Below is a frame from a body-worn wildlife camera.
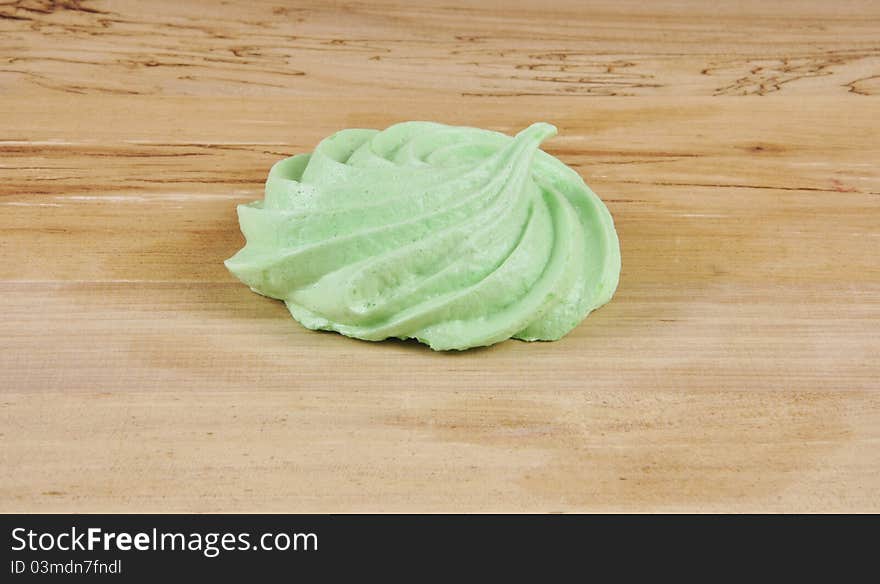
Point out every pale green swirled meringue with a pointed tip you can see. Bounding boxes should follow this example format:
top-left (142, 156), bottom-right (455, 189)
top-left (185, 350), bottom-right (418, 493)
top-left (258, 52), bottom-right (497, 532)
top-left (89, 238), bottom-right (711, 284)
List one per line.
top-left (226, 122), bottom-right (620, 350)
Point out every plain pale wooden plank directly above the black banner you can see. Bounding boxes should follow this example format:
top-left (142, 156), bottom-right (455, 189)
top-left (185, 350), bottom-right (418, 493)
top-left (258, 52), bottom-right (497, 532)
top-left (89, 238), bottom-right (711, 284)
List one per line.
top-left (0, 388), bottom-right (880, 512)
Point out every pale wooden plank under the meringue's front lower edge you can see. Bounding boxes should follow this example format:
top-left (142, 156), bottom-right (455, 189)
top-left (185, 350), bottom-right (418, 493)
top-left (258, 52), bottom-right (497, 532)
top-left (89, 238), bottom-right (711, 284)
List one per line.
top-left (0, 279), bottom-right (880, 394)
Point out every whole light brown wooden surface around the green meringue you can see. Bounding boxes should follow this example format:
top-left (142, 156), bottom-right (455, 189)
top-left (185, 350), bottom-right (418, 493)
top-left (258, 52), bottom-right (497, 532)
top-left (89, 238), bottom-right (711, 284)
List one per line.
top-left (0, 0), bottom-right (880, 512)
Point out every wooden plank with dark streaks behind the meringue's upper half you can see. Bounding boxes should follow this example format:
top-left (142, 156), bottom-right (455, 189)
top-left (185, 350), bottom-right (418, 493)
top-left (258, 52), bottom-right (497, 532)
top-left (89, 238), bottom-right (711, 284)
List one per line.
top-left (0, 96), bottom-right (880, 288)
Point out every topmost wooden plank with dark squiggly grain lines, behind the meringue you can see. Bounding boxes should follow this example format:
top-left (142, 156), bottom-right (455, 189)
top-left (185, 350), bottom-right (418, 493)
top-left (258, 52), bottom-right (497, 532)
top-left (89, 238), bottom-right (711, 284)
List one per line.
top-left (0, 0), bottom-right (880, 97)
